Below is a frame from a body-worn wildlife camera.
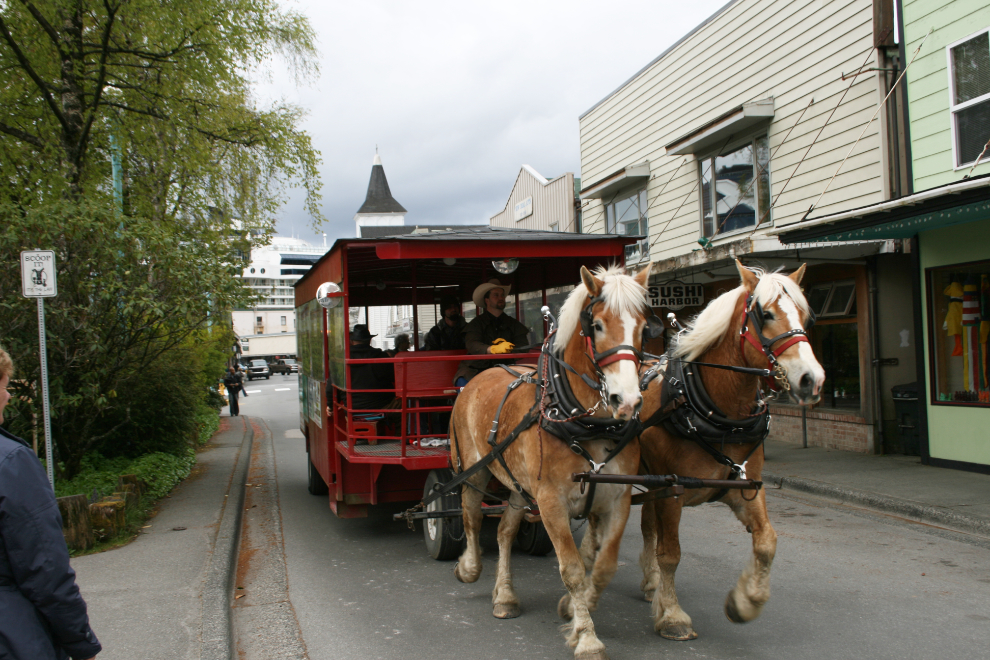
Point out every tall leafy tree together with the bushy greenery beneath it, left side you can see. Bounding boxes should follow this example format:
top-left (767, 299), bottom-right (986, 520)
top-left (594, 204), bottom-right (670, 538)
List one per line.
top-left (0, 0), bottom-right (321, 478)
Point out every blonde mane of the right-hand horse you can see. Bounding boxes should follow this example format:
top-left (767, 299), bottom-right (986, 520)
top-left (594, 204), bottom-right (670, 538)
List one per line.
top-left (674, 268), bottom-right (808, 361)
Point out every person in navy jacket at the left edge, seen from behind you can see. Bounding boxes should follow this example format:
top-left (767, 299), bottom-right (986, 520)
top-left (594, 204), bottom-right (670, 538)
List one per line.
top-left (0, 348), bottom-right (103, 660)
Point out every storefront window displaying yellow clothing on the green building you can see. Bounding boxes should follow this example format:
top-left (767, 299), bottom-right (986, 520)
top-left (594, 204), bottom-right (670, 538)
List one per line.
top-left (928, 261), bottom-right (990, 405)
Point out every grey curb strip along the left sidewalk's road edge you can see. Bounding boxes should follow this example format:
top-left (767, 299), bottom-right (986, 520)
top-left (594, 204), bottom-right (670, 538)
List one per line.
top-left (200, 417), bottom-right (254, 660)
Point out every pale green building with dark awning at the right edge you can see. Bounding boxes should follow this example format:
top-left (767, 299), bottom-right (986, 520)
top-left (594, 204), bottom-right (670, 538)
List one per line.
top-left (780, 0), bottom-right (990, 473)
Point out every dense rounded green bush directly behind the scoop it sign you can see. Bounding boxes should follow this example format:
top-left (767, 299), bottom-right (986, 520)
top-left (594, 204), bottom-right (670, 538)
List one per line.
top-left (0, 201), bottom-right (250, 478)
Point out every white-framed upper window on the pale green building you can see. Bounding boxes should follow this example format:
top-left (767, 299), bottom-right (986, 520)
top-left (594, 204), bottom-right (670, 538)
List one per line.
top-left (948, 30), bottom-right (990, 168)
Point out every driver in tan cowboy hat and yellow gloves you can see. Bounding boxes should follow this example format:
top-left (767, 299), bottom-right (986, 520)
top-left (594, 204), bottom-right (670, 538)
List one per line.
top-left (454, 280), bottom-right (529, 387)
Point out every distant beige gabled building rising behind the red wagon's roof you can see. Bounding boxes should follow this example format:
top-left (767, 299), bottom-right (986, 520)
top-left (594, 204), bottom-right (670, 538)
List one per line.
top-left (489, 165), bottom-right (579, 232)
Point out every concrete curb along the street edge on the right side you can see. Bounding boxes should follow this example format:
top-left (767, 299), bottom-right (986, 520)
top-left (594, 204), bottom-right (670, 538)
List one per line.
top-left (763, 472), bottom-right (990, 537)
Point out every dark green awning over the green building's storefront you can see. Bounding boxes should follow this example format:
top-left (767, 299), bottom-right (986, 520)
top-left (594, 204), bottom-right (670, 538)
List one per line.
top-left (767, 174), bottom-right (990, 244)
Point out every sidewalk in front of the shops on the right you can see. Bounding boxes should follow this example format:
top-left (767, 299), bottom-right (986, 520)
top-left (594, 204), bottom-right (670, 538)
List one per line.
top-left (763, 440), bottom-right (990, 537)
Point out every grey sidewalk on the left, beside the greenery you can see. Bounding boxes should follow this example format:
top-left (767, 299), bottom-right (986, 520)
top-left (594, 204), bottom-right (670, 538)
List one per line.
top-left (72, 416), bottom-right (253, 660)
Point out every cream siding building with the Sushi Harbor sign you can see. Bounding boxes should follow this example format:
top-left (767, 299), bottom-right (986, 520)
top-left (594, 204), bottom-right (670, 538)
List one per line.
top-left (579, 0), bottom-right (914, 452)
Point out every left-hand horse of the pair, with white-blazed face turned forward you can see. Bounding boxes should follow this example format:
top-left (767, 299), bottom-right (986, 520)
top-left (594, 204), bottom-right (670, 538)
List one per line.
top-left (450, 266), bottom-right (652, 660)
